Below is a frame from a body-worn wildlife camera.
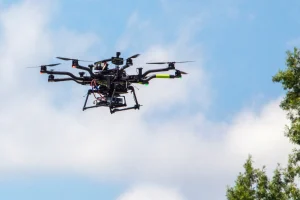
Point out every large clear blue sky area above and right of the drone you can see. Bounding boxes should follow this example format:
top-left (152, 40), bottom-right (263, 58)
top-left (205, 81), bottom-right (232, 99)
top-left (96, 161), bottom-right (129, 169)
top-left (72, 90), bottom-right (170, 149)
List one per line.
top-left (45, 1), bottom-right (300, 119)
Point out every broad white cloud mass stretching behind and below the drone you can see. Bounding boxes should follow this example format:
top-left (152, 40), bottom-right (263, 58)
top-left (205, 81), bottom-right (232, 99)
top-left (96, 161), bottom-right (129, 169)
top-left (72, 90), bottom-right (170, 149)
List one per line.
top-left (0, 1), bottom-right (291, 200)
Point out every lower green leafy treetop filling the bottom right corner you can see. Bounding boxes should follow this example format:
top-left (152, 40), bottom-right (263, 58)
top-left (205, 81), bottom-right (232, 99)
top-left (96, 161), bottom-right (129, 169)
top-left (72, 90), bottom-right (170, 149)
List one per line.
top-left (226, 155), bottom-right (300, 200)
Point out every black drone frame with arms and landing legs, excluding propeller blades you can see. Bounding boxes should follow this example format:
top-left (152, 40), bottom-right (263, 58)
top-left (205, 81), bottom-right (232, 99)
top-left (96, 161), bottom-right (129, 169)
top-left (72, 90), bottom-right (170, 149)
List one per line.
top-left (40, 55), bottom-right (186, 114)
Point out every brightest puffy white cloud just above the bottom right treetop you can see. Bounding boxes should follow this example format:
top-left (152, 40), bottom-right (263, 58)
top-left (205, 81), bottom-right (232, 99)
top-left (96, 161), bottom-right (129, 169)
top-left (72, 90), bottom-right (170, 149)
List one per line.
top-left (228, 98), bottom-right (291, 167)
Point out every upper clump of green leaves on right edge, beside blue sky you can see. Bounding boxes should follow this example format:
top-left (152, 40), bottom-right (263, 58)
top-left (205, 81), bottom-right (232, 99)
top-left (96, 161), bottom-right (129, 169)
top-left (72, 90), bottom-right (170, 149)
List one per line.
top-left (272, 48), bottom-right (300, 145)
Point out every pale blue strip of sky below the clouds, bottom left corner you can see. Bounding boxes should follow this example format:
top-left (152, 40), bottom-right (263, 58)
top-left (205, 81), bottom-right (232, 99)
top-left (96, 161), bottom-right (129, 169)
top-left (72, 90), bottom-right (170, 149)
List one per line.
top-left (0, 176), bottom-right (123, 200)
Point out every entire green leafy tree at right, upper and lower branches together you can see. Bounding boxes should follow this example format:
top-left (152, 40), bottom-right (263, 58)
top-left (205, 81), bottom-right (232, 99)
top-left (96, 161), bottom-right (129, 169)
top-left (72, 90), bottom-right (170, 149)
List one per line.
top-left (226, 48), bottom-right (300, 200)
